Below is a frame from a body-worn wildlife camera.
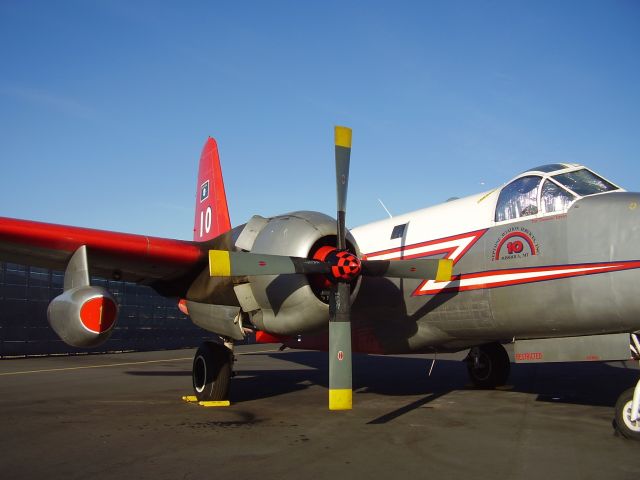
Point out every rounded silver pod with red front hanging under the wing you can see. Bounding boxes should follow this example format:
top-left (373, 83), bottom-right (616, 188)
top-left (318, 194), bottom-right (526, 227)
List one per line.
top-left (47, 285), bottom-right (118, 348)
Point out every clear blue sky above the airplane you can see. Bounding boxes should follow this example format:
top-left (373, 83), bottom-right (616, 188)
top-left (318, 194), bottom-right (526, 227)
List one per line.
top-left (0, 0), bottom-right (640, 239)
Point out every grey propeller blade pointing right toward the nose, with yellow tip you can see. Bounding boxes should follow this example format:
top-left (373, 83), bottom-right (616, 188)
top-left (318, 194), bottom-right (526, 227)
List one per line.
top-left (362, 258), bottom-right (453, 282)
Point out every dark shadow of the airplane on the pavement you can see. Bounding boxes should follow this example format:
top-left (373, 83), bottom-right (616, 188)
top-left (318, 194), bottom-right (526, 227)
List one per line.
top-left (126, 351), bottom-right (640, 423)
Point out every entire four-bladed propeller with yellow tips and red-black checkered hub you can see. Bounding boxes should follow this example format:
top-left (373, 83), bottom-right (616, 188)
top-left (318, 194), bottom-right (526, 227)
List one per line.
top-left (209, 126), bottom-right (453, 410)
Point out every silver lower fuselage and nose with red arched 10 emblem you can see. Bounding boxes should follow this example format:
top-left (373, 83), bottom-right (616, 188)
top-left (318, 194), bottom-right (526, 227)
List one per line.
top-left (353, 192), bottom-right (640, 353)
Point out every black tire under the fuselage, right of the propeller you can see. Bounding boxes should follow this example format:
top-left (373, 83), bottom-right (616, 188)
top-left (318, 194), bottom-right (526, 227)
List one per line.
top-left (467, 343), bottom-right (511, 388)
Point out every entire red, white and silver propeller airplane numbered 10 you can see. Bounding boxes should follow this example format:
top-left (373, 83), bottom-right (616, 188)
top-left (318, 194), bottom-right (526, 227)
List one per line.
top-left (0, 127), bottom-right (640, 440)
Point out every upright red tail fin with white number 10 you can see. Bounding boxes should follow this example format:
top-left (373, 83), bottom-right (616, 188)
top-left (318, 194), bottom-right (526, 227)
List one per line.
top-left (193, 137), bottom-right (231, 242)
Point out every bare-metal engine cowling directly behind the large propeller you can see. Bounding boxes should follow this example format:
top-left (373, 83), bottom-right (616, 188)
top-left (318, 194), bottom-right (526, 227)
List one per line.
top-left (240, 211), bottom-right (360, 335)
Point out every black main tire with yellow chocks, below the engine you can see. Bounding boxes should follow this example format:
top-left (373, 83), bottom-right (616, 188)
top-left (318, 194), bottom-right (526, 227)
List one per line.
top-left (191, 342), bottom-right (232, 402)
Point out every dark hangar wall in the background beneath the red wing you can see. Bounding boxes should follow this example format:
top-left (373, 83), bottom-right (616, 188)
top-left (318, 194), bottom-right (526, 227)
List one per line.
top-left (0, 263), bottom-right (218, 358)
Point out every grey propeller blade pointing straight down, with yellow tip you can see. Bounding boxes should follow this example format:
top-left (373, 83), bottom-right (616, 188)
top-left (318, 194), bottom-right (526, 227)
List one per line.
top-left (329, 282), bottom-right (353, 410)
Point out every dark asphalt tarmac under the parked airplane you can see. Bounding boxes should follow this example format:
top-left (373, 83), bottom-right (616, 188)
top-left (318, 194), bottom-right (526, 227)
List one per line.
top-left (0, 345), bottom-right (640, 480)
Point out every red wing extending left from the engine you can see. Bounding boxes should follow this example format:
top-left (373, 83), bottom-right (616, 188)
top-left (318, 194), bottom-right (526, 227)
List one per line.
top-left (0, 217), bottom-right (206, 284)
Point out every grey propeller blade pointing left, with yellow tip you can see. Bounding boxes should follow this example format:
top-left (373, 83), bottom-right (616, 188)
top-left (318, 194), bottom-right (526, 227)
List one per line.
top-left (209, 250), bottom-right (331, 277)
